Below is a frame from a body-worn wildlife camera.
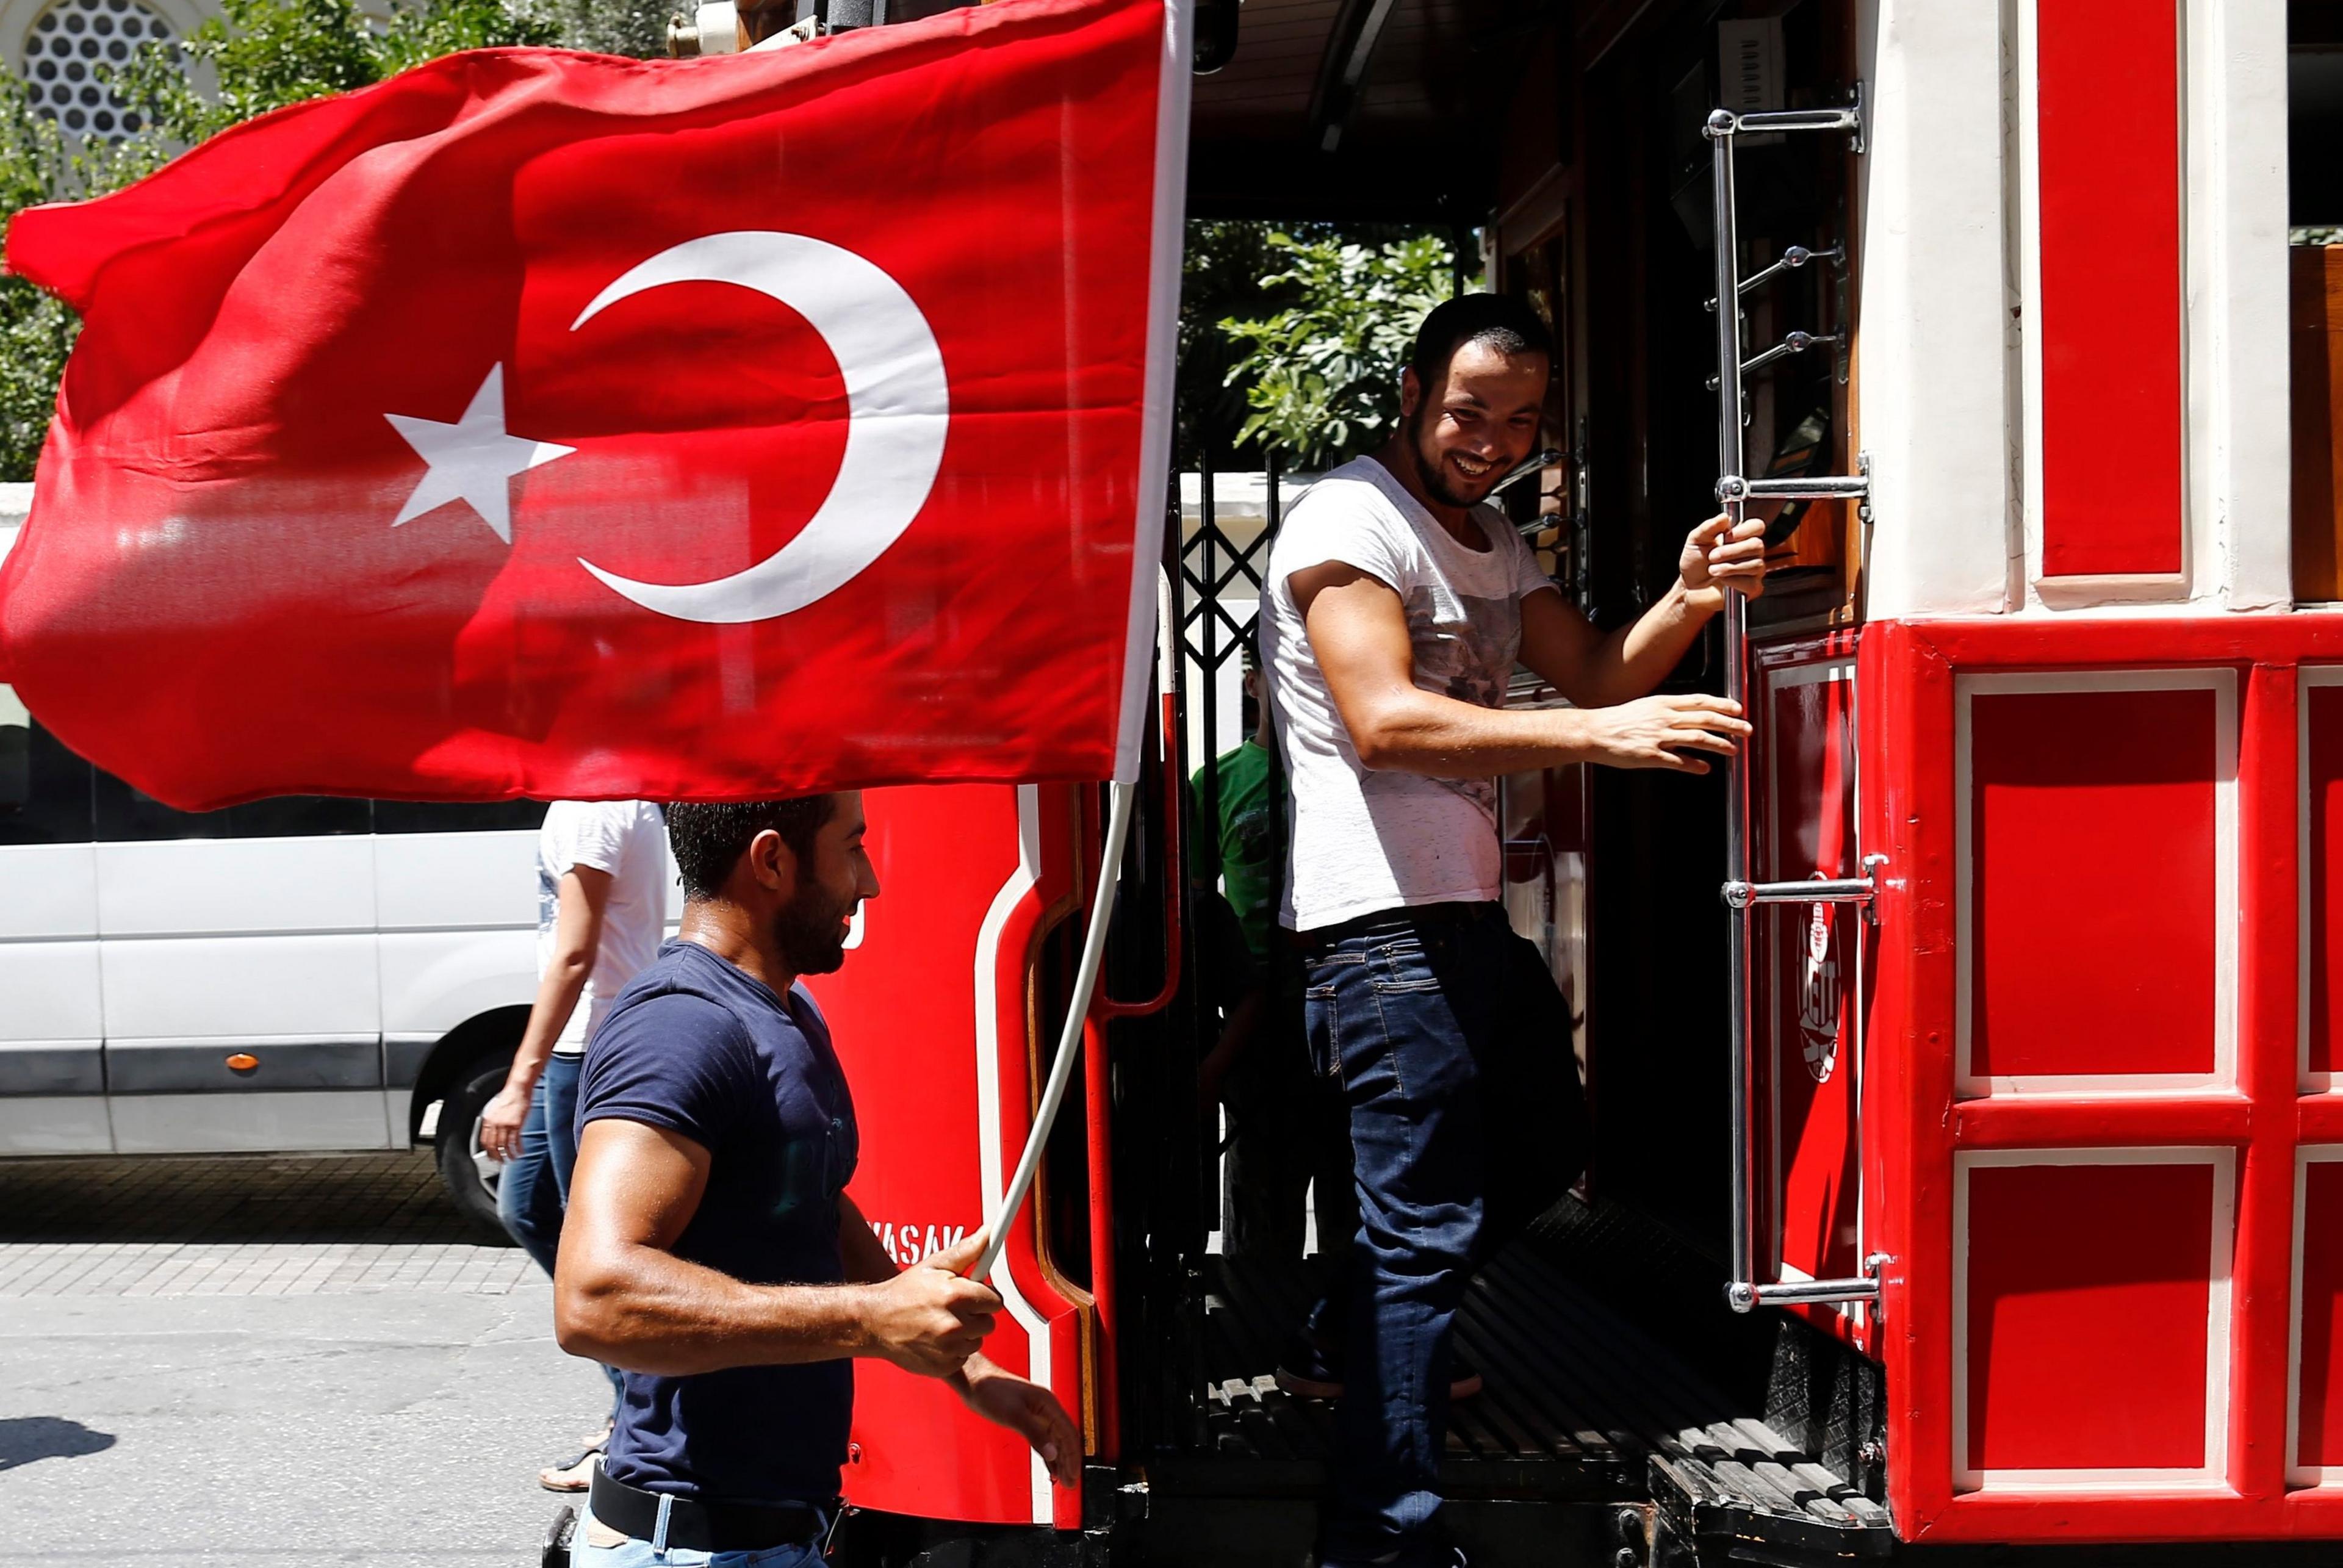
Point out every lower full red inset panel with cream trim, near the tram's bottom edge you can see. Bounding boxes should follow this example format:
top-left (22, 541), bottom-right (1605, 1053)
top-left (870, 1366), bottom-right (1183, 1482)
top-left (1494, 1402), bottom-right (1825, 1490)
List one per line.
top-left (1966, 1165), bottom-right (2228, 1470)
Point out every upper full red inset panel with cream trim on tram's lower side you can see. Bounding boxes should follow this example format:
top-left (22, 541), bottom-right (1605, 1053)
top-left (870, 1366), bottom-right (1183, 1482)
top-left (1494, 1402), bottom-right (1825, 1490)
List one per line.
top-left (1968, 689), bottom-right (2217, 1078)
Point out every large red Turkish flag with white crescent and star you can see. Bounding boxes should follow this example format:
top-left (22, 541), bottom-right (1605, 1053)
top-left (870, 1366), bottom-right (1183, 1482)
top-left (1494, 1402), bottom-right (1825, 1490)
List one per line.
top-left (0, 0), bottom-right (1188, 808)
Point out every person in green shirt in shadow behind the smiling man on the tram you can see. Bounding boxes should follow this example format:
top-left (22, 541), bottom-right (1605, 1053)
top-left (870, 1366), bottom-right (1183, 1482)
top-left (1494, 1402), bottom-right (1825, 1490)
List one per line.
top-left (1188, 638), bottom-right (1359, 1261)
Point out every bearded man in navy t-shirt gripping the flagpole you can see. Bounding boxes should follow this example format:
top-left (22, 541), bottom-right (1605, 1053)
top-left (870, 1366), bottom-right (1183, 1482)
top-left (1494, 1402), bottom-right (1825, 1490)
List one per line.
top-left (553, 792), bottom-right (1082, 1568)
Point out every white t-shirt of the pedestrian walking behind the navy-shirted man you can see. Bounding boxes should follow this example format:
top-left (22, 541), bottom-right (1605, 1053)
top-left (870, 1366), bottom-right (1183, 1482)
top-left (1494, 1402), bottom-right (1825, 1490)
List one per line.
top-left (536, 799), bottom-right (668, 1057)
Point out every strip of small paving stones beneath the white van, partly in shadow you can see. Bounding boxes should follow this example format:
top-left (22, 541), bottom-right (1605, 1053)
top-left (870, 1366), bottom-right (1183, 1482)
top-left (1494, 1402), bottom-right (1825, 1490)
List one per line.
top-left (0, 1151), bottom-right (536, 1298)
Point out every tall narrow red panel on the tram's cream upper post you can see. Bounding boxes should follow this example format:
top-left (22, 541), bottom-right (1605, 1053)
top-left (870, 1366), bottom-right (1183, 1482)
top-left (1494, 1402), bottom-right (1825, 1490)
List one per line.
top-left (2034, 0), bottom-right (2181, 577)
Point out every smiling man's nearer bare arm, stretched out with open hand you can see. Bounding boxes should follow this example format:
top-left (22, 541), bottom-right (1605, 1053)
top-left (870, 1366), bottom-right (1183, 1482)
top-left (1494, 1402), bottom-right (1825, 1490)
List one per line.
top-left (1286, 560), bottom-right (1748, 778)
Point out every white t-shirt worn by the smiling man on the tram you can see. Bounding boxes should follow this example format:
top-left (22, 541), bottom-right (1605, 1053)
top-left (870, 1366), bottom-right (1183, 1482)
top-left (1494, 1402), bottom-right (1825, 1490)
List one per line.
top-left (1261, 457), bottom-right (1553, 930)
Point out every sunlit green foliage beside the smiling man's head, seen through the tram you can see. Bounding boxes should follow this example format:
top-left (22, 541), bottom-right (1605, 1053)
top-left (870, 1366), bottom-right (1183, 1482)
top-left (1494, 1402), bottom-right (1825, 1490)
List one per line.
top-left (1218, 232), bottom-right (1455, 469)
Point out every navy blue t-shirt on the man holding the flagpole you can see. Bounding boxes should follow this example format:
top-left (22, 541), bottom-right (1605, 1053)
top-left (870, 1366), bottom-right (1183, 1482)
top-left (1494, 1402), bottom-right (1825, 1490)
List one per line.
top-left (578, 942), bottom-right (857, 1505)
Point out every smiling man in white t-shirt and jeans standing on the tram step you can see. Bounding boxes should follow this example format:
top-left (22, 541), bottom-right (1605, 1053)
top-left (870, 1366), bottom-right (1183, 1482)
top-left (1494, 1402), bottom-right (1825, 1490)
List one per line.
top-left (1261, 295), bottom-right (1765, 1568)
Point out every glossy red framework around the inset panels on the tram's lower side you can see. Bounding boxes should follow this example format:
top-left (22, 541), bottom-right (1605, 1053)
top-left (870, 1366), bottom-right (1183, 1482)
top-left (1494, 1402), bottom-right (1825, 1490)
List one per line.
top-left (1860, 612), bottom-right (2343, 1556)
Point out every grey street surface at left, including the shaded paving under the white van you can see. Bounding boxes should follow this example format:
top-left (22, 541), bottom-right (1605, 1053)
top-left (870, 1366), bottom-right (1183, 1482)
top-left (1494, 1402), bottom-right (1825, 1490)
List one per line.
top-left (0, 1156), bottom-right (607, 1568)
